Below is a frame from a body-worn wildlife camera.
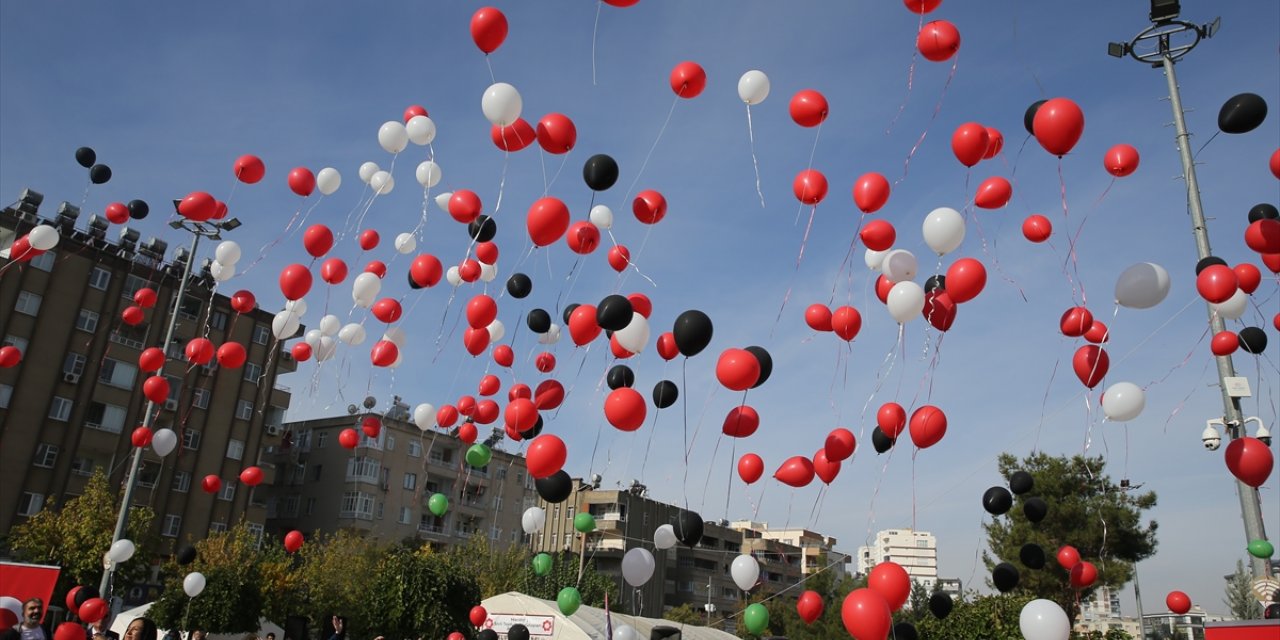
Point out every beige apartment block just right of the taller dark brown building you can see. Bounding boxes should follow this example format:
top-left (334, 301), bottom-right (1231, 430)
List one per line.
top-left (264, 398), bottom-right (538, 547)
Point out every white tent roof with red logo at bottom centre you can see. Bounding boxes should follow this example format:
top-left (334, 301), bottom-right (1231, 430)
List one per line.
top-left (481, 591), bottom-right (737, 640)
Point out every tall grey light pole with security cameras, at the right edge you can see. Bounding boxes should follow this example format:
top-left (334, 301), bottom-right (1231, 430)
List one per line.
top-left (1107, 5), bottom-right (1270, 580)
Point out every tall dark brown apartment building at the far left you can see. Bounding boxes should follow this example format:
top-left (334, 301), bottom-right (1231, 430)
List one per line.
top-left (0, 189), bottom-right (296, 550)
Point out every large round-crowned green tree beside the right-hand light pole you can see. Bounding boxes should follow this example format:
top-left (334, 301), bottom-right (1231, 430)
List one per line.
top-left (983, 453), bottom-right (1156, 626)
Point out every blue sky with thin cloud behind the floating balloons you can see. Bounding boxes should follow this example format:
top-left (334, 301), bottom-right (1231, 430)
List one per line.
top-left (0, 0), bottom-right (1280, 613)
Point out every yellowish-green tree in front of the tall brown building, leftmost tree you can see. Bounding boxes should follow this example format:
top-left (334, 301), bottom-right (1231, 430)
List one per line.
top-left (9, 470), bottom-right (157, 602)
